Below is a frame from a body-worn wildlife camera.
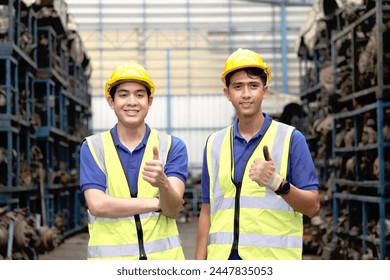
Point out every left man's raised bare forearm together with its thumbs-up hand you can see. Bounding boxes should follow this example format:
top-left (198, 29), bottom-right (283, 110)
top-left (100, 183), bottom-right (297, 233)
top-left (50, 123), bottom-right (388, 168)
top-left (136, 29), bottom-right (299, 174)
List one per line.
top-left (142, 147), bottom-right (185, 218)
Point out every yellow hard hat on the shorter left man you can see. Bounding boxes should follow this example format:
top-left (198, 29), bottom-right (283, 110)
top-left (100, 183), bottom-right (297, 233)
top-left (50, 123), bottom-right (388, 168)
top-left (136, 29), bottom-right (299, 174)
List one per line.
top-left (104, 61), bottom-right (155, 99)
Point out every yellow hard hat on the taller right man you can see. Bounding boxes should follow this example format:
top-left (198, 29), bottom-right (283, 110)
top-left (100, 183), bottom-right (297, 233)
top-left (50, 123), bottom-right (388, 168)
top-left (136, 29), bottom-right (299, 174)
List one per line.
top-left (221, 48), bottom-right (272, 85)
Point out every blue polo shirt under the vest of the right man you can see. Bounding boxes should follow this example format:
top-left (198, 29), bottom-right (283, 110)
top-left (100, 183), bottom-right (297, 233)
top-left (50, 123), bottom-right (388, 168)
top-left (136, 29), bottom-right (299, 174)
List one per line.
top-left (202, 113), bottom-right (318, 203)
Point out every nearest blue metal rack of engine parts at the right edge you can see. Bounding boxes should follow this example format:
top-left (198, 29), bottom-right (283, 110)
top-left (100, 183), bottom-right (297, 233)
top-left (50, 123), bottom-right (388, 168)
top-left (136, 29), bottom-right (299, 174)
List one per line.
top-left (332, 1), bottom-right (390, 259)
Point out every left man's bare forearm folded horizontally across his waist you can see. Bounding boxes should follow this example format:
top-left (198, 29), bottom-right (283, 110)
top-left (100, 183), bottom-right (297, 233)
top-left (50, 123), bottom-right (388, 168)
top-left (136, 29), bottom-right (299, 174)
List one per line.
top-left (84, 189), bottom-right (160, 218)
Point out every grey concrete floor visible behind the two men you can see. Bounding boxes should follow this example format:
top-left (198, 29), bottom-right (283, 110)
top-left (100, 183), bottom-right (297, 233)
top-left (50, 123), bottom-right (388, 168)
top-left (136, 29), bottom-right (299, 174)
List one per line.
top-left (38, 217), bottom-right (198, 260)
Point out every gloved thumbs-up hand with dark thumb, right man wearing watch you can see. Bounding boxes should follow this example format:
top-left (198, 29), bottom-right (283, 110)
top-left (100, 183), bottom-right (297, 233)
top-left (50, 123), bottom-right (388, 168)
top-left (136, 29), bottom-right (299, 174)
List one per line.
top-left (249, 146), bottom-right (283, 191)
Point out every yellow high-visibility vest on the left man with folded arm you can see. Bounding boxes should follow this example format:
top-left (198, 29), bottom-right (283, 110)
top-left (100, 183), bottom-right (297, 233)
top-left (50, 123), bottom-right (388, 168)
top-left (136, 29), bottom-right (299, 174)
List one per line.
top-left (86, 129), bottom-right (184, 260)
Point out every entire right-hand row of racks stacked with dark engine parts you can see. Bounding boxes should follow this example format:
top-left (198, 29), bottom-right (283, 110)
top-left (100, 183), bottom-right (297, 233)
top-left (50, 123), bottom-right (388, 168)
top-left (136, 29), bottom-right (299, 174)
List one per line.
top-left (297, 0), bottom-right (390, 259)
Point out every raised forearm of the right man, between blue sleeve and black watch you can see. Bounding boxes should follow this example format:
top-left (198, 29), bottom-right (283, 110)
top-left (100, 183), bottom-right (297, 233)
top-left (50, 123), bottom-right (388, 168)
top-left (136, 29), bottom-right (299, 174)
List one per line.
top-left (282, 187), bottom-right (320, 217)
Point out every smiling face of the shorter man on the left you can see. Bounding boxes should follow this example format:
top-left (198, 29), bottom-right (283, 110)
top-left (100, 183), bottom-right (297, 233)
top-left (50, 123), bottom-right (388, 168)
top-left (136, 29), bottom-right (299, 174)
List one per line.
top-left (108, 82), bottom-right (153, 128)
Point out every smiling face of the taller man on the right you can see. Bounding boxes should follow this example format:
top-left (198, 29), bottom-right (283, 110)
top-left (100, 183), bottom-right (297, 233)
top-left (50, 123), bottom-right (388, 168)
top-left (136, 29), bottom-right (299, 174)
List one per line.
top-left (224, 70), bottom-right (268, 120)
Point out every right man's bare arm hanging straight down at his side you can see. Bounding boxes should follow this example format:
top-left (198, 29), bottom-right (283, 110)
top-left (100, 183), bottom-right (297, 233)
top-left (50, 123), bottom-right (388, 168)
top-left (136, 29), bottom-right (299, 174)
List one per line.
top-left (195, 203), bottom-right (210, 260)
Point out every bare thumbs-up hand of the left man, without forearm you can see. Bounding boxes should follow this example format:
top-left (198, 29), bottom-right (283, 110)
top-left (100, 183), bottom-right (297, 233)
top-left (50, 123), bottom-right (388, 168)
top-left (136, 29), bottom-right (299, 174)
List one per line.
top-left (142, 147), bottom-right (169, 188)
